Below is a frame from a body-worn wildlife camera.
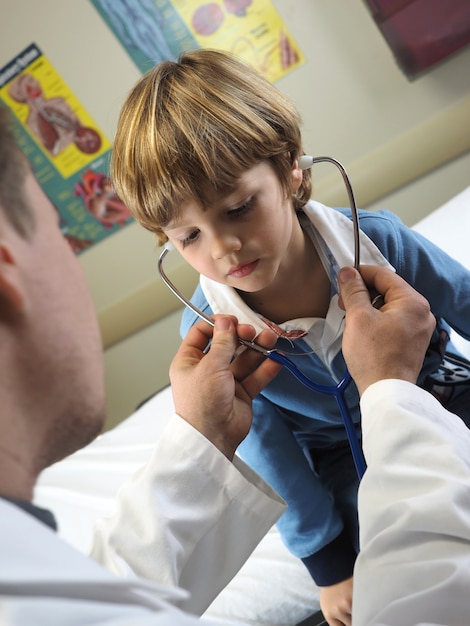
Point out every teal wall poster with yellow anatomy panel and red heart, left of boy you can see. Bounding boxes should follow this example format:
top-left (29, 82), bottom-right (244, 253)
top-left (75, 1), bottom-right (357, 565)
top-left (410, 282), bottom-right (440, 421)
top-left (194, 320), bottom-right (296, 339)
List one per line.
top-left (0, 44), bottom-right (132, 253)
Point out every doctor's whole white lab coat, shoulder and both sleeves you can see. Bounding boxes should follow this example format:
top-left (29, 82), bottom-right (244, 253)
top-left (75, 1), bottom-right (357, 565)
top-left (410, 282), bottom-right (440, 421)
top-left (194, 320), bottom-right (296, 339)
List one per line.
top-left (4, 380), bottom-right (470, 626)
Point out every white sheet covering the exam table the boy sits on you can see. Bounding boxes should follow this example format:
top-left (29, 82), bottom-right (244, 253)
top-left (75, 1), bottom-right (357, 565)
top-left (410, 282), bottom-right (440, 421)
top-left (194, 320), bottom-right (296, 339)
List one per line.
top-left (35, 187), bottom-right (470, 626)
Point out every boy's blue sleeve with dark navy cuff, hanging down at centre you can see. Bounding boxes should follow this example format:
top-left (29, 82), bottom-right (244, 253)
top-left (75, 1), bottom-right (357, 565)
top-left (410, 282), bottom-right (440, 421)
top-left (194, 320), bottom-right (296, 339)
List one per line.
top-left (238, 395), bottom-right (356, 586)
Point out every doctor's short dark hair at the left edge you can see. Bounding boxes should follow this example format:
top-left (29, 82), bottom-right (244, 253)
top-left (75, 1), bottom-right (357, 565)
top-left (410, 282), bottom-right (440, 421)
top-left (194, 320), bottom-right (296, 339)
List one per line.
top-left (0, 105), bottom-right (35, 237)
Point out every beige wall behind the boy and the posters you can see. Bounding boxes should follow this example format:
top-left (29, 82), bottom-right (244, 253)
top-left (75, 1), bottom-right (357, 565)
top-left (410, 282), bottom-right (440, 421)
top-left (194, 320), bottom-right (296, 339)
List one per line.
top-left (0, 0), bottom-right (470, 423)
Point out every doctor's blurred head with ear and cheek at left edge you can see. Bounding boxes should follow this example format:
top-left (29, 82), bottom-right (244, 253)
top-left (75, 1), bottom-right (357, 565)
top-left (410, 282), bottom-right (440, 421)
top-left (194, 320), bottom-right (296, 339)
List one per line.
top-left (0, 107), bottom-right (104, 499)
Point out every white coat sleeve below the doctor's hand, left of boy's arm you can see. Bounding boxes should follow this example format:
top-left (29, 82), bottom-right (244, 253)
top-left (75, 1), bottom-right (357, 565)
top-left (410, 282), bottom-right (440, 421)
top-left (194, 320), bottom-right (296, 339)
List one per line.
top-left (92, 415), bottom-right (285, 615)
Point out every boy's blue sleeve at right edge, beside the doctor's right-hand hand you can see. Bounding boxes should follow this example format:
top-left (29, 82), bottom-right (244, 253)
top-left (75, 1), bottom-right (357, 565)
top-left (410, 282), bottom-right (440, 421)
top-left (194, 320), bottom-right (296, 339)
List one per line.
top-left (360, 211), bottom-right (470, 339)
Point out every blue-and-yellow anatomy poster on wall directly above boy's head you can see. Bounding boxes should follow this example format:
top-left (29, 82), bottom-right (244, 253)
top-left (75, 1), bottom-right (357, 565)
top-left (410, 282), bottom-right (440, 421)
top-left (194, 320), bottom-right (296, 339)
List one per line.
top-left (90, 0), bottom-right (305, 82)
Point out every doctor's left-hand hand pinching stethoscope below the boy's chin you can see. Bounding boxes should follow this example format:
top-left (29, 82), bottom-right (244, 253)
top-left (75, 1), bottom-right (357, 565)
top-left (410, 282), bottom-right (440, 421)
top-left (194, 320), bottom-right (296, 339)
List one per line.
top-left (170, 315), bottom-right (281, 460)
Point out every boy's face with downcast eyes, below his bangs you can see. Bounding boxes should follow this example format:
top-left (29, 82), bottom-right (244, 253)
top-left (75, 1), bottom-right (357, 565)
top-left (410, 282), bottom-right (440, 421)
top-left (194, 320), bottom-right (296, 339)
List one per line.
top-left (164, 162), bottom-right (303, 293)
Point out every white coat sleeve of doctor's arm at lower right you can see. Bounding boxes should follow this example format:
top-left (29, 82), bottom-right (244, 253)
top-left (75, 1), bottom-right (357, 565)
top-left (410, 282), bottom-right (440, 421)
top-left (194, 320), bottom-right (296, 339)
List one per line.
top-left (353, 380), bottom-right (470, 626)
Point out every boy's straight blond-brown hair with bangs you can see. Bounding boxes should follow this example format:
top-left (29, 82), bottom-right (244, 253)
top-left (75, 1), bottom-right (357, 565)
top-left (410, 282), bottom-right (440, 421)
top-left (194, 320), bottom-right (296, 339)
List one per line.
top-left (111, 49), bottom-right (311, 243)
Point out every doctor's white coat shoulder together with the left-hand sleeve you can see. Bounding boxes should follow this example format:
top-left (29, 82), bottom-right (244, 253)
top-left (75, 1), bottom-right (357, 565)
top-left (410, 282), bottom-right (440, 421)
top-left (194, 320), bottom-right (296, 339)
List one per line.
top-left (0, 416), bottom-right (284, 626)
